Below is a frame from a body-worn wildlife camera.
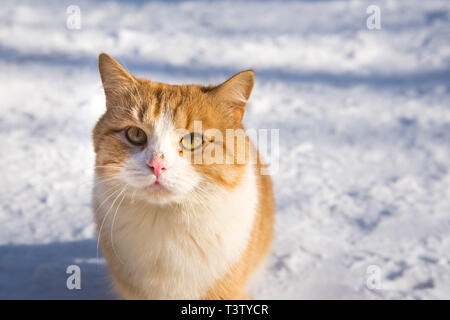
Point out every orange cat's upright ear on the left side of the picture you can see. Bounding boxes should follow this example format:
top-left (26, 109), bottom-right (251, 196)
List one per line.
top-left (98, 53), bottom-right (136, 107)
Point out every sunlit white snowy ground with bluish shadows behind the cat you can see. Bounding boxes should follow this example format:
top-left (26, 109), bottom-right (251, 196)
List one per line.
top-left (0, 0), bottom-right (450, 299)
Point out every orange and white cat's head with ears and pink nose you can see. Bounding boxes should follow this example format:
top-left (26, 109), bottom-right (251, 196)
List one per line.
top-left (93, 54), bottom-right (253, 203)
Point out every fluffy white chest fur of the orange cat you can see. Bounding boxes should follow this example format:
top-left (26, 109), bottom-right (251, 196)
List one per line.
top-left (94, 166), bottom-right (258, 299)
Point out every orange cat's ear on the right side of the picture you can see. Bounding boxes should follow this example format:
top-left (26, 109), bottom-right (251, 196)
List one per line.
top-left (210, 70), bottom-right (255, 123)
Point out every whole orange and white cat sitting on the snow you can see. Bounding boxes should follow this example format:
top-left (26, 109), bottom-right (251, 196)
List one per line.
top-left (92, 53), bottom-right (274, 299)
